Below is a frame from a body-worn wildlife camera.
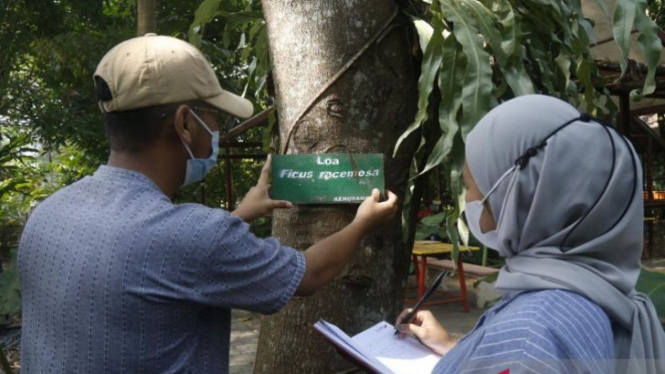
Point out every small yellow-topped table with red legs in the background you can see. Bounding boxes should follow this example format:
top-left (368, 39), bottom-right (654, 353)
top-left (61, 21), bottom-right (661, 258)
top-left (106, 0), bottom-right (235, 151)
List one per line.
top-left (406, 240), bottom-right (481, 313)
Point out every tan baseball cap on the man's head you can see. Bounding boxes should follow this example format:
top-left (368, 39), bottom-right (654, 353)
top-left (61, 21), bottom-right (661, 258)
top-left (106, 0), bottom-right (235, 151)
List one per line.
top-left (95, 34), bottom-right (254, 118)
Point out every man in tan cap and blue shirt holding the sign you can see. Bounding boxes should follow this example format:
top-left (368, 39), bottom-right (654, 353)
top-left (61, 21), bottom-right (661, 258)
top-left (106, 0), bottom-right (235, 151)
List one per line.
top-left (19, 35), bottom-right (396, 373)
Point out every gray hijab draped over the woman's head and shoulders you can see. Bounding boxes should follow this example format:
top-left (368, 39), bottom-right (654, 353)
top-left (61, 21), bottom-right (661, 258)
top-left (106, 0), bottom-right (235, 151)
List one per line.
top-left (466, 95), bottom-right (665, 373)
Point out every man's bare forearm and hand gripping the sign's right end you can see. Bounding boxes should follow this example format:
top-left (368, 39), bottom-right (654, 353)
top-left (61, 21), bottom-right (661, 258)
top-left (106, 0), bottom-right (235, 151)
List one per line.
top-left (296, 189), bottom-right (397, 296)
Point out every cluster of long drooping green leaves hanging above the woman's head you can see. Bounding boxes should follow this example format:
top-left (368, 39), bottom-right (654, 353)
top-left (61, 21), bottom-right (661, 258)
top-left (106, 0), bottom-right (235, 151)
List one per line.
top-left (396, 0), bottom-right (661, 260)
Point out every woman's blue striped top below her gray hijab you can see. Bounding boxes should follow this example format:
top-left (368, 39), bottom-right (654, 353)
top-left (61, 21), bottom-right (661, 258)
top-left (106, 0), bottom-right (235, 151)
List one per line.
top-left (432, 290), bottom-right (614, 374)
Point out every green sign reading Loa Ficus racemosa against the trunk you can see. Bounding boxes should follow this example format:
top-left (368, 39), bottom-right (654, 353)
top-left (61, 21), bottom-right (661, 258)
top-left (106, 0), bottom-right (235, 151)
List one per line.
top-left (272, 153), bottom-right (384, 204)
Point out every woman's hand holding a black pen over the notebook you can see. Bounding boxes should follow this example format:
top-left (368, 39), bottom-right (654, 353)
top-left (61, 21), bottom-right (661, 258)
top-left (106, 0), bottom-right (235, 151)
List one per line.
top-left (395, 309), bottom-right (457, 356)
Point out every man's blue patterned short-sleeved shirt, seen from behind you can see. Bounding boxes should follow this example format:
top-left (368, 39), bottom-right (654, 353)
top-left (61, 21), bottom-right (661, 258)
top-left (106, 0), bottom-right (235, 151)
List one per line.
top-left (19, 166), bottom-right (305, 374)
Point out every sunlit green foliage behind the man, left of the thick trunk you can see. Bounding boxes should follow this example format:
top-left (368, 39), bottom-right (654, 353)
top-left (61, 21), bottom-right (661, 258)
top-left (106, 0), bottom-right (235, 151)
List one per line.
top-left (0, 0), bottom-right (268, 238)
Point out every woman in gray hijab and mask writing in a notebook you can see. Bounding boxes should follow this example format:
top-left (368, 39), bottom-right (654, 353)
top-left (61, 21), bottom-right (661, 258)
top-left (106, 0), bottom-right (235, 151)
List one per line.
top-left (397, 95), bottom-right (665, 374)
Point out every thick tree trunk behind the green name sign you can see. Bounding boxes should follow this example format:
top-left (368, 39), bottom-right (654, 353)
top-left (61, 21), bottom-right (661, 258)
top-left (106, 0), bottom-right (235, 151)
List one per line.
top-left (254, 0), bottom-right (419, 374)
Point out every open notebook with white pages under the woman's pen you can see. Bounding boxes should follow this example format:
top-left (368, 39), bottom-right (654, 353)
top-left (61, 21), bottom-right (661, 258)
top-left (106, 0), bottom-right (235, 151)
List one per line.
top-left (314, 319), bottom-right (440, 374)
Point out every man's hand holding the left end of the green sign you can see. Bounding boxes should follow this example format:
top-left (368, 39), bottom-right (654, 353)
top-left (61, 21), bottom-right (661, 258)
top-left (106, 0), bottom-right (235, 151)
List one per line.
top-left (231, 155), bottom-right (293, 223)
